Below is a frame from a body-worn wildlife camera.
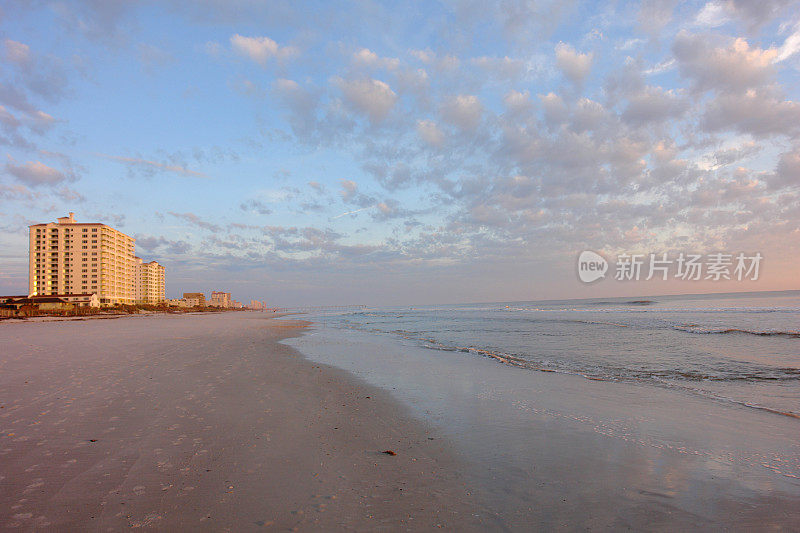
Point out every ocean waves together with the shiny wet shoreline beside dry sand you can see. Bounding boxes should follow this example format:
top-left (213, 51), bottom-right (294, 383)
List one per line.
top-left (285, 291), bottom-right (800, 530)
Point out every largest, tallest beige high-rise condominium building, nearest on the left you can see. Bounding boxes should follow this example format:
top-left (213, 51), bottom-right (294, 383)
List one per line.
top-left (28, 213), bottom-right (138, 305)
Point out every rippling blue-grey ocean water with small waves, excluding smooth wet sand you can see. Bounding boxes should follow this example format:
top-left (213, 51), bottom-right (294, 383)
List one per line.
top-left (298, 291), bottom-right (800, 418)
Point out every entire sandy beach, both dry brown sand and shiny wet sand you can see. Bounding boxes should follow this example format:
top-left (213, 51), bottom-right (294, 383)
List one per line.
top-left (0, 312), bottom-right (800, 531)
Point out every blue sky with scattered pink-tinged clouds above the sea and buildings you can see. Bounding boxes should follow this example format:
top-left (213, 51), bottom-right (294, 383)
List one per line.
top-left (0, 0), bottom-right (800, 306)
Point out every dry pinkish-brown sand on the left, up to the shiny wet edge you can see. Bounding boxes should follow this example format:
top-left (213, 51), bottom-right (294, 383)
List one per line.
top-left (0, 313), bottom-right (490, 531)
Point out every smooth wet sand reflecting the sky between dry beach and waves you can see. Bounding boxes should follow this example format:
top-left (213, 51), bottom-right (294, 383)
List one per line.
top-left (287, 328), bottom-right (800, 529)
